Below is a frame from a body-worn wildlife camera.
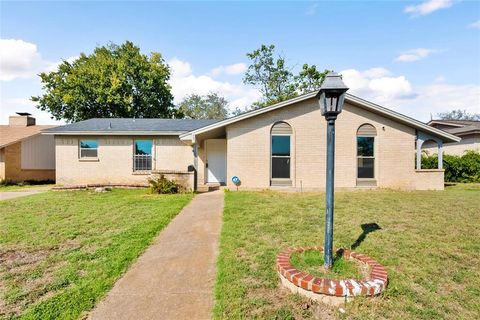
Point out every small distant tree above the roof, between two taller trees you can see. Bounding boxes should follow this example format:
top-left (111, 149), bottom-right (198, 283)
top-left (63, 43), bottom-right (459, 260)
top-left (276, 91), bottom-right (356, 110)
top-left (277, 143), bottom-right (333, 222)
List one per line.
top-left (178, 93), bottom-right (228, 120)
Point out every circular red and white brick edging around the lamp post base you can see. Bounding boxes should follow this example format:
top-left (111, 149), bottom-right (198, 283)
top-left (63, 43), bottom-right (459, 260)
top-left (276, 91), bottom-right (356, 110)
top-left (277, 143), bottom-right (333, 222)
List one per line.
top-left (276, 246), bottom-right (388, 297)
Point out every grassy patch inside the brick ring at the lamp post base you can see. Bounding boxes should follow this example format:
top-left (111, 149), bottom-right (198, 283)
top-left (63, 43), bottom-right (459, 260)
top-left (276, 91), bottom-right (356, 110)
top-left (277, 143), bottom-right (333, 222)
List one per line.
top-left (290, 250), bottom-right (369, 279)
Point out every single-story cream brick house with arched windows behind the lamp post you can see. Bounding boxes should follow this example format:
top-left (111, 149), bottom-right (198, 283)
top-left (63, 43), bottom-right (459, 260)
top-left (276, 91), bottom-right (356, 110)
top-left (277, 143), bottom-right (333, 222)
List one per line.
top-left (44, 92), bottom-right (460, 190)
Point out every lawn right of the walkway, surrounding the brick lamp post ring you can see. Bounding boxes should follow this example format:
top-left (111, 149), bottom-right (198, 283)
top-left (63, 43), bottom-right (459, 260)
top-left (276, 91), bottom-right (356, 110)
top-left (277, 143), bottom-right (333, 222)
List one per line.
top-left (214, 189), bottom-right (480, 319)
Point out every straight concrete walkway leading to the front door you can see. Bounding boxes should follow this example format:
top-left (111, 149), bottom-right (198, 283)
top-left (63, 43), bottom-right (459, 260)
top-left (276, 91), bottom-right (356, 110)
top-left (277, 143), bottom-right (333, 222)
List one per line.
top-left (89, 191), bottom-right (223, 320)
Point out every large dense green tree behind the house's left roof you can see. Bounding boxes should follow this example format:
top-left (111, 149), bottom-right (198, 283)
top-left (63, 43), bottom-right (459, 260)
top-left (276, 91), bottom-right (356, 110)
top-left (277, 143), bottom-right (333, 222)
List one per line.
top-left (31, 41), bottom-right (176, 122)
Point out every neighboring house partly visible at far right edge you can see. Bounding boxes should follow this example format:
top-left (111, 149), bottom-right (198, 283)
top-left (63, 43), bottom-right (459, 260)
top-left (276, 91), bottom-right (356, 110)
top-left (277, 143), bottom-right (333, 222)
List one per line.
top-left (422, 120), bottom-right (480, 156)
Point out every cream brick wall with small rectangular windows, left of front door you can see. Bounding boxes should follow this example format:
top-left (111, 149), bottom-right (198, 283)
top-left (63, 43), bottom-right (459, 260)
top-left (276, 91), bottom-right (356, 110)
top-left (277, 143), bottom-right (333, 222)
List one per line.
top-left (55, 136), bottom-right (197, 185)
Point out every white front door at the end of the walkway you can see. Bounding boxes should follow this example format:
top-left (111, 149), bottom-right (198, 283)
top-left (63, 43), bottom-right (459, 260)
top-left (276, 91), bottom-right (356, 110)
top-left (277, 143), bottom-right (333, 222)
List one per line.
top-left (205, 139), bottom-right (227, 183)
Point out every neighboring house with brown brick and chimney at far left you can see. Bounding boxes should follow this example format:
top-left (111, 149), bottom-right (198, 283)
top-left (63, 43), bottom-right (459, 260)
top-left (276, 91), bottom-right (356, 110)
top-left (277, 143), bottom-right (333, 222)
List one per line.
top-left (0, 113), bottom-right (55, 182)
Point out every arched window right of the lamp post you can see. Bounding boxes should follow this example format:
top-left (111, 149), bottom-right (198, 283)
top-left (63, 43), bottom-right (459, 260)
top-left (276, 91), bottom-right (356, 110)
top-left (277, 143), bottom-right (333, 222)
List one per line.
top-left (357, 124), bottom-right (377, 179)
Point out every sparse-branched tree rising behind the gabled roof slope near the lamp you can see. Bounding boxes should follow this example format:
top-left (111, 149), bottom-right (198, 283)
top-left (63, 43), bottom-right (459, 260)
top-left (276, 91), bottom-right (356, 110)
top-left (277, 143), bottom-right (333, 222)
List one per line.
top-left (243, 45), bottom-right (328, 108)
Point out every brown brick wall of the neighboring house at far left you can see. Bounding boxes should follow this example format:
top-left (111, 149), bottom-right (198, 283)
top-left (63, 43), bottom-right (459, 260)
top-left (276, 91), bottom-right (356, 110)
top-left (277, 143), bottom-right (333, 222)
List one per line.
top-left (0, 142), bottom-right (55, 182)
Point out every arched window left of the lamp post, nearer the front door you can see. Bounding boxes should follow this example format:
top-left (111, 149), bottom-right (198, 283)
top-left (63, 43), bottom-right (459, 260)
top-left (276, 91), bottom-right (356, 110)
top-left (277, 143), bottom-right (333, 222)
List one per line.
top-left (270, 122), bottom-right (292, 186)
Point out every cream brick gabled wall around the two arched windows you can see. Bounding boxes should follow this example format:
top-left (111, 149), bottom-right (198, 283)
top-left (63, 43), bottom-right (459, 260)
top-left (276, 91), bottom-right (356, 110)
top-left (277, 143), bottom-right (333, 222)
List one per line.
top-left (218, 99), bottom-right (443, 190)
